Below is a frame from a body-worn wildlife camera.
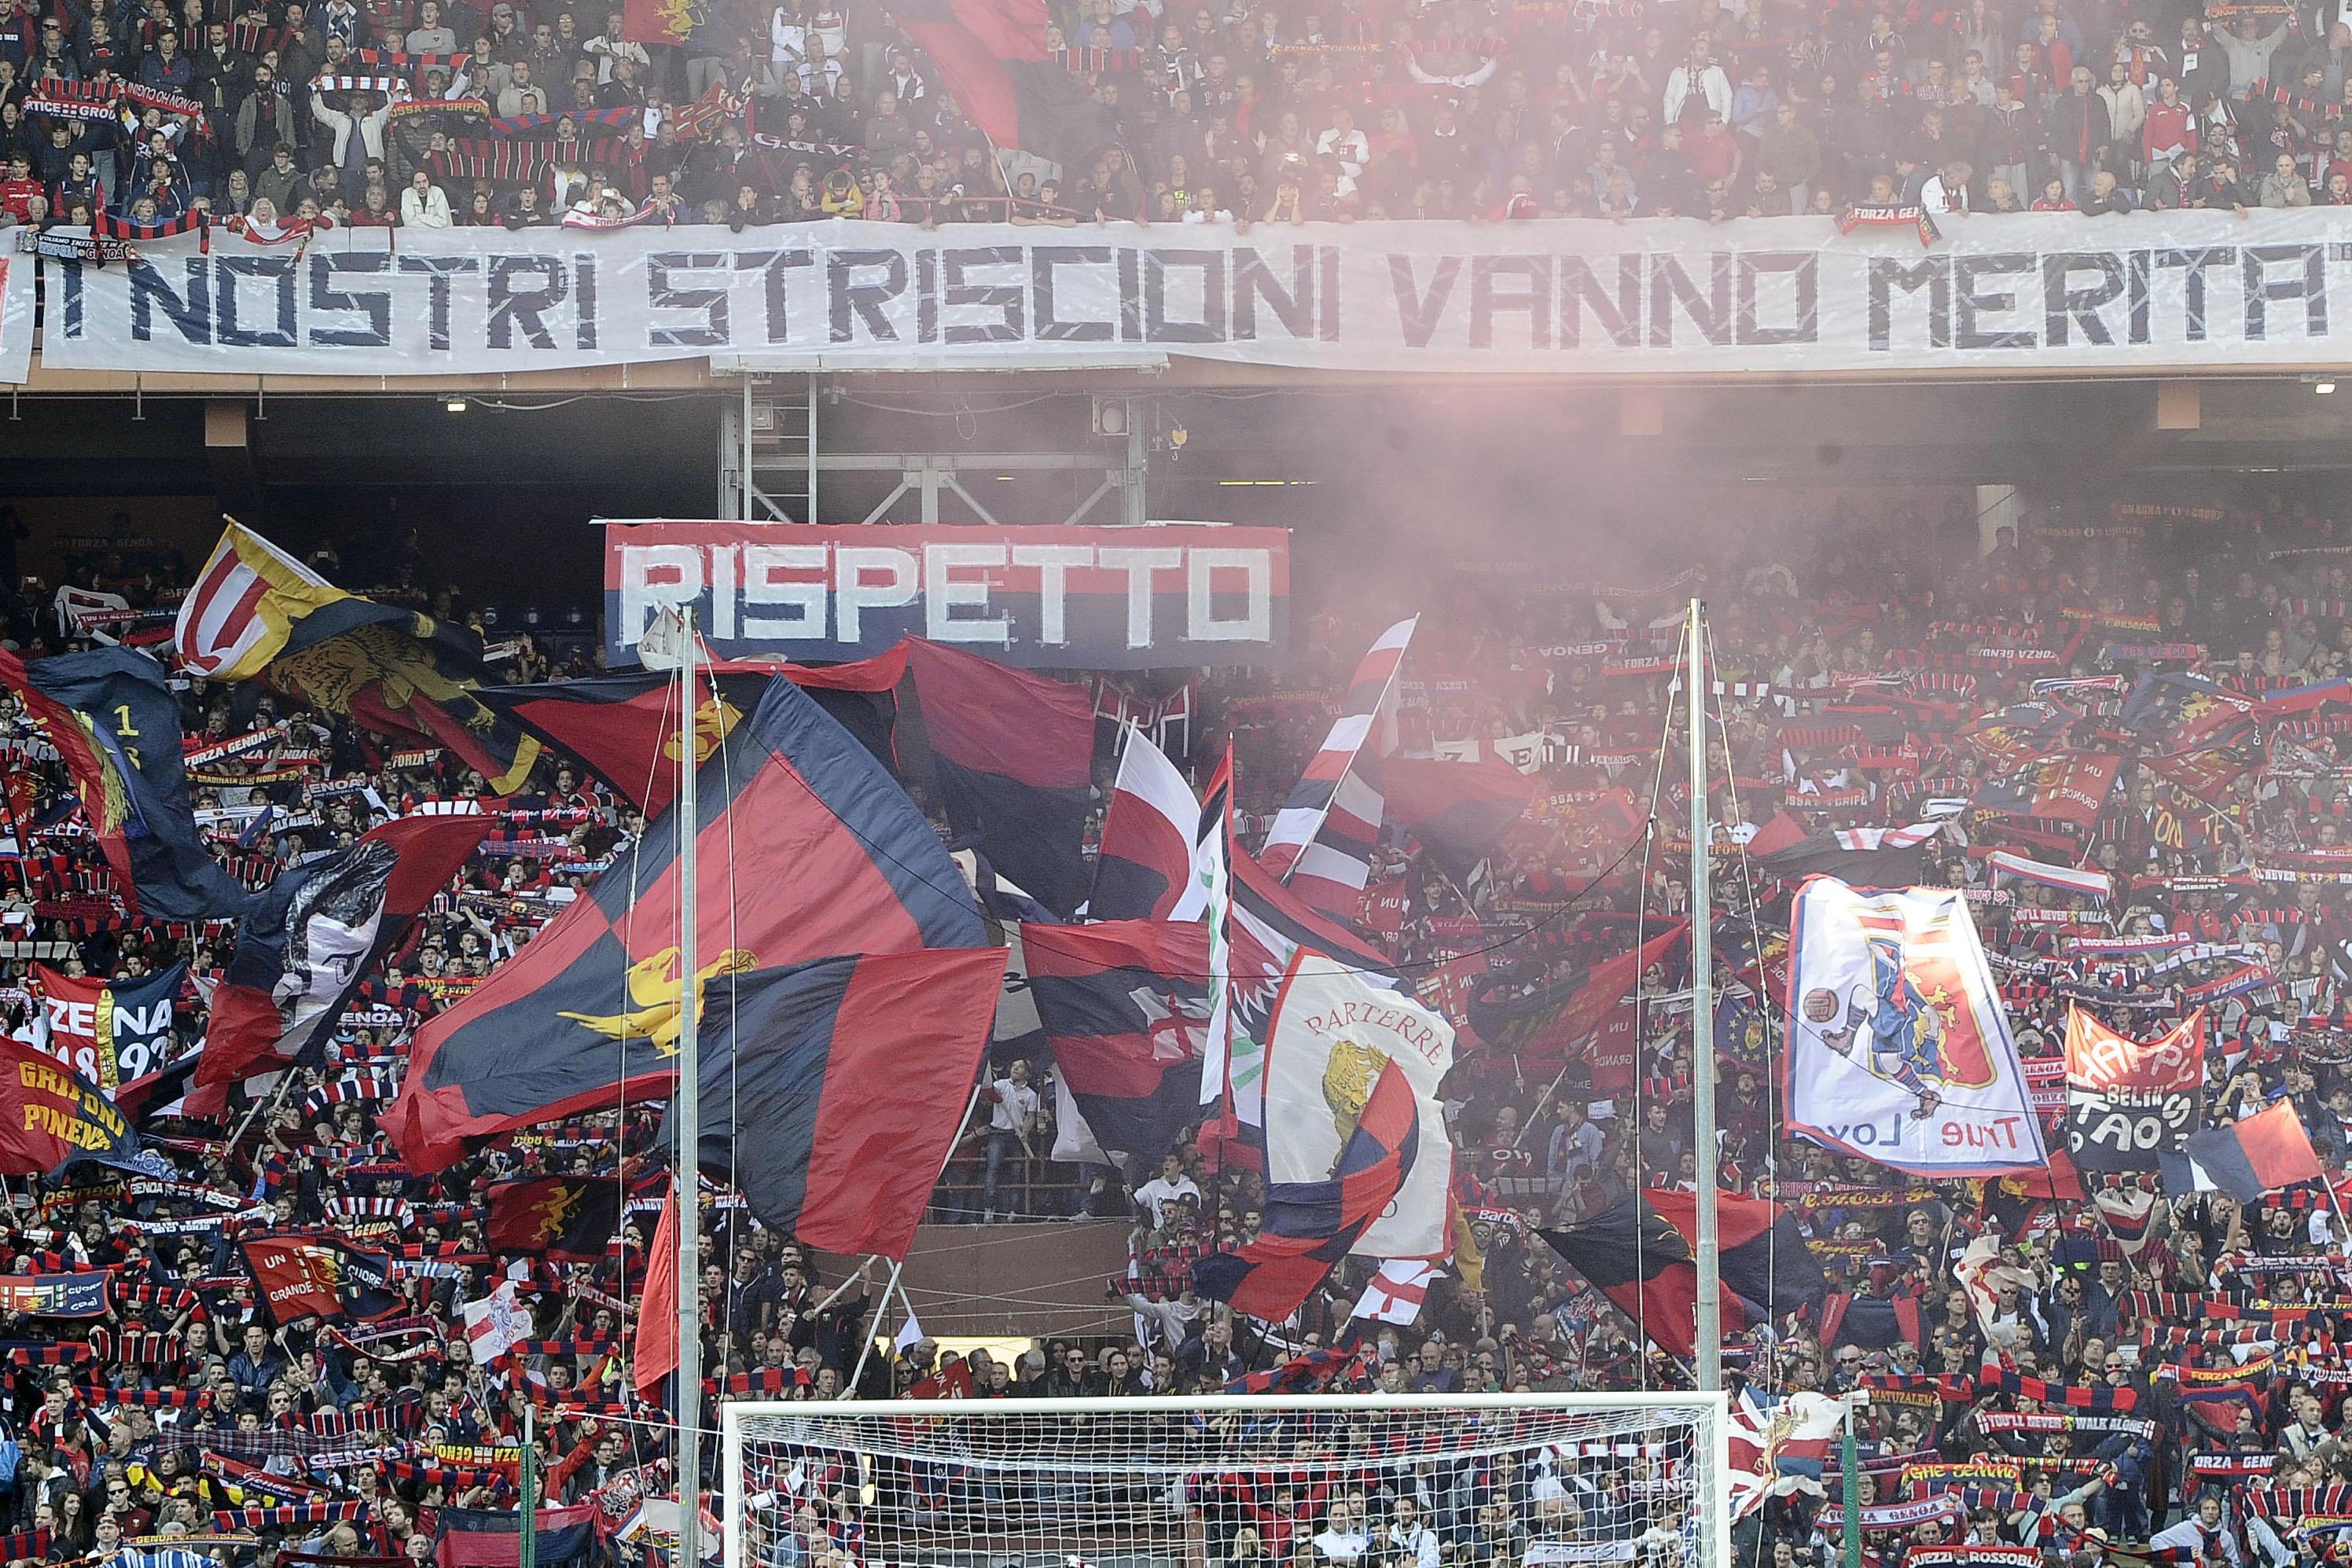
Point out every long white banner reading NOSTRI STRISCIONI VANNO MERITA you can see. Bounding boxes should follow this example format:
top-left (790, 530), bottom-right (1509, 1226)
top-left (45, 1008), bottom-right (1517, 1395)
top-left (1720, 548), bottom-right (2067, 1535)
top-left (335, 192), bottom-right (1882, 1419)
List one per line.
top-left (31, 207), bottom-right (2352, 379)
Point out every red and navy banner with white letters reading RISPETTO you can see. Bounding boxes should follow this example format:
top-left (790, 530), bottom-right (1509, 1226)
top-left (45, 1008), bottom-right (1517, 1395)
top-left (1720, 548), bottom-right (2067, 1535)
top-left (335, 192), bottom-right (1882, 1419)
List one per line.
top-left (605, 522), bottom-right (1292, 670)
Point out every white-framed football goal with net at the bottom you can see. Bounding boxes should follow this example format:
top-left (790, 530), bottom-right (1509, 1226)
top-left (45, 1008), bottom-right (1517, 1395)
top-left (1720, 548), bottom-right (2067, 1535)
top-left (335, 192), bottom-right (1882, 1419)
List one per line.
top-left (722, 1394), bottom-right (1731, 1568)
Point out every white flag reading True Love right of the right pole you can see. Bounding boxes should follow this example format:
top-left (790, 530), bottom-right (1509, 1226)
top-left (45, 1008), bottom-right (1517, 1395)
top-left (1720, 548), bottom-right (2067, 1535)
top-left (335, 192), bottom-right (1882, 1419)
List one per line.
top-left (1785, 877), bottom-right (2049, 1177)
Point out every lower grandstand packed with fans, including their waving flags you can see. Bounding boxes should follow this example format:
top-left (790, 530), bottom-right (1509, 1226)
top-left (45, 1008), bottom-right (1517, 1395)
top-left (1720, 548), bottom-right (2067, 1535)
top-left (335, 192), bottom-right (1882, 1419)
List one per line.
top-left (0, 494), bottom-right (2352, 1568)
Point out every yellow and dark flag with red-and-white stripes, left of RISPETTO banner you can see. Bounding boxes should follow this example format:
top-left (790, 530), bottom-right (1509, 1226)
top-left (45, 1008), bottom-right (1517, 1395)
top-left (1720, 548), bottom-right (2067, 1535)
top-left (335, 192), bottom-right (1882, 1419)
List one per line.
top-left (171, 522), bottom-right (538, 795)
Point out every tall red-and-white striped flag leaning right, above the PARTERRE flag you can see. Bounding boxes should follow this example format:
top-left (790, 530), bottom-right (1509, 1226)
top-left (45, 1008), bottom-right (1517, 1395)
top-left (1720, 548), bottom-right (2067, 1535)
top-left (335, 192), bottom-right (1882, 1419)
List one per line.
top-left (1259, 616), bottom-right (1420, 915)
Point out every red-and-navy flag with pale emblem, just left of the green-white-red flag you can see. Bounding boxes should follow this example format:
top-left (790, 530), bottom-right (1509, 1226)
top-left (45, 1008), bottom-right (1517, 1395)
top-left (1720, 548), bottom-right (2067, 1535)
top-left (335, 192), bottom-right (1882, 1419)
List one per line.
top-left (1021, 919), bottom-right (1209, 1162)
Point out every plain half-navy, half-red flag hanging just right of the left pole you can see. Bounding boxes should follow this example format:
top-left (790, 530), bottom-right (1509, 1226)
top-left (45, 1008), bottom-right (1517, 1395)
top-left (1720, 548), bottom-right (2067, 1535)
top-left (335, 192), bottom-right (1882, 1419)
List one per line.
top-left (663, 947), bottom-right (1005, 1260)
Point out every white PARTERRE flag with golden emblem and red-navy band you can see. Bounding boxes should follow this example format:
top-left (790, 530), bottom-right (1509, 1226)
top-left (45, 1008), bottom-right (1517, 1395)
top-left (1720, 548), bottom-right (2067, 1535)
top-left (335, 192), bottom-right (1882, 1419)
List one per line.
top-left (1193, 947), bottom-right (1453, 1324)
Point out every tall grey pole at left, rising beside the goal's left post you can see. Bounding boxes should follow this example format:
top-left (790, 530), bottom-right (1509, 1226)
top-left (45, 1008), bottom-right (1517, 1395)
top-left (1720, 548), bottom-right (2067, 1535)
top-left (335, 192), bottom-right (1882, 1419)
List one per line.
top-left (671, 609), bottom-right (704, 1568)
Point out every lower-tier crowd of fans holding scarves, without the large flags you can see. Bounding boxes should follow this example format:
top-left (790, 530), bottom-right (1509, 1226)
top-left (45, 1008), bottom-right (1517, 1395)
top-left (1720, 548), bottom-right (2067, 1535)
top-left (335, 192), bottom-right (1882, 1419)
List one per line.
top-left (0, 494), bottom-right (2352, 1568)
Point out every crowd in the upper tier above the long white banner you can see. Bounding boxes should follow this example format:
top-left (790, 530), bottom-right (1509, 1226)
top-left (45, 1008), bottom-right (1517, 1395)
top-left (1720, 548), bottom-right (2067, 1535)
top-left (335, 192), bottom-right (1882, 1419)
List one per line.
top-left (0, 0), bottom-right (2352, 233)
